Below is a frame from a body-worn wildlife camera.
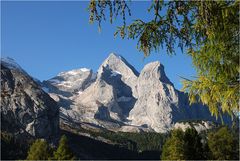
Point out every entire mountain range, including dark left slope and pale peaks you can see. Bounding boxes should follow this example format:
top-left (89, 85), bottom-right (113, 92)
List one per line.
top-left (1, 53), bottom-right (231, 137)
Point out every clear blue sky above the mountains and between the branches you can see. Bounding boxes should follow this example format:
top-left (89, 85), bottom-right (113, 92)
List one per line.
top-left (1, 1), bottom-right (195, 89)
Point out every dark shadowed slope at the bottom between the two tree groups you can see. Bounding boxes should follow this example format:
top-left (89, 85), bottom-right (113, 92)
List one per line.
top-left (61, 130), bottom-right (160, 160)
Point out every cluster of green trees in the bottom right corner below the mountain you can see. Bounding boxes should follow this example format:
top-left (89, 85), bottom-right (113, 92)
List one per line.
top-left (161, 127), bottom-right (239, 160)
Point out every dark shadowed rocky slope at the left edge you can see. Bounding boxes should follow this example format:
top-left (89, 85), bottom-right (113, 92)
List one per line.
top-left (1, 60), bottom-right (59, 139)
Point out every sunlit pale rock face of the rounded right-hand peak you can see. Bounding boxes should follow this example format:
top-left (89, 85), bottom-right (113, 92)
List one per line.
top-left (129, 62), bottom-right (179, 132)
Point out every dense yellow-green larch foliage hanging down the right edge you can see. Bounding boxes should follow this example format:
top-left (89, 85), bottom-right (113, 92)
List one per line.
top-left (184, 1), bottom-right (240, 116)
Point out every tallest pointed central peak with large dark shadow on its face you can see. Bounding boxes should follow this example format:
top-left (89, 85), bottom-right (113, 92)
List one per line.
top-left (52, 53), bottom-right (138, 129)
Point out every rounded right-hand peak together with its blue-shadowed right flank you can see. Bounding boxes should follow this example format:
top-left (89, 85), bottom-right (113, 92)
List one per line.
top-left (128, 62), bottom-right (225, 132)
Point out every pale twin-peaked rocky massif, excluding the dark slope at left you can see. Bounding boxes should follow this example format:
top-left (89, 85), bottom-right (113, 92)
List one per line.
top-left (43, 53), bottom-right (231, 132)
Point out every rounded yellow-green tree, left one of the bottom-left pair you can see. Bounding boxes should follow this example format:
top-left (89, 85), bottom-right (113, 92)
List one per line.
top-left (27, 139), bottom-right (52, 160)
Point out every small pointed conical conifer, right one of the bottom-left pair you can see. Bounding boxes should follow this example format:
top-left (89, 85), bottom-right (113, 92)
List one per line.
top-left (53, 135), bottom-right (75, 160)
